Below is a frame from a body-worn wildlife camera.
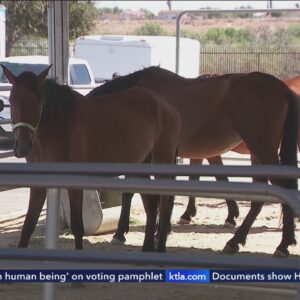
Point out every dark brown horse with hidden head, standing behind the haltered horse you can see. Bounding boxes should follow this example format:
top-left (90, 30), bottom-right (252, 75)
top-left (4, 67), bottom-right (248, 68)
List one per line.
top-left (89, 67), bottom-right (298, 255)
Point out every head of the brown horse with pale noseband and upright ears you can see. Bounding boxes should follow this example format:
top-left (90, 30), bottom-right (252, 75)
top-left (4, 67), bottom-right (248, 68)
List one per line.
top-left (1, 65), bottom-right (51, 157)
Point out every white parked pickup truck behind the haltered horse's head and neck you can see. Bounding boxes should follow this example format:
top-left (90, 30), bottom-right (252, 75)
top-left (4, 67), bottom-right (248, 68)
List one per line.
top-left (0, 56), bottom-right (96, 97)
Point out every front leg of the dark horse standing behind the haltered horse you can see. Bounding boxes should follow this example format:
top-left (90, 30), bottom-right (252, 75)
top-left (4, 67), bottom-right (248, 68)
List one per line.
top-left (112, 193), bottom-right (134, 244)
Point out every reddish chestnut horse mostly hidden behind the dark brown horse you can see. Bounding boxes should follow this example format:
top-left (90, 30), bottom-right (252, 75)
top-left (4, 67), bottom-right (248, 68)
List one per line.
top-left (179, 74), bottom-right (300, 227)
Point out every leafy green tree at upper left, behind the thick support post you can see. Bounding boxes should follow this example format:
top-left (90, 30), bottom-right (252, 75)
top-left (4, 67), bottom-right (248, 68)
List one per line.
top-left (0, 0), bottom-right (98, 55)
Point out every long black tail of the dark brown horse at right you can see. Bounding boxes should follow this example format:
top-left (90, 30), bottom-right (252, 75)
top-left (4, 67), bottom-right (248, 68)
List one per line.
top-left (279, 91), bottom-right (298, 190)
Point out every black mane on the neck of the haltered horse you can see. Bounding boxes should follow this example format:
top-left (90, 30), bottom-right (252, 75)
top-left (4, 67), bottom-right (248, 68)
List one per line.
top-left (41, 79), bottom-right (77, 120)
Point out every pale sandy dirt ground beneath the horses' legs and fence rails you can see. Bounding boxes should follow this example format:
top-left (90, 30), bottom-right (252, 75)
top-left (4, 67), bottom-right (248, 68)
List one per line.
top-left (0, 196), bottom-right (300, 300)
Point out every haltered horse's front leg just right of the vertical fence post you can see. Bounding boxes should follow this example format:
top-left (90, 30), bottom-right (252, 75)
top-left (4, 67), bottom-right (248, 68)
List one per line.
top-left (68, 190), bottom-right (84, 249)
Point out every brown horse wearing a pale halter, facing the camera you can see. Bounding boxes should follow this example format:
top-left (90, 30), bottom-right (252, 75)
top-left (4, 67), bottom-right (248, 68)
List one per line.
top-left (2, 66), bottom-right (181, 252)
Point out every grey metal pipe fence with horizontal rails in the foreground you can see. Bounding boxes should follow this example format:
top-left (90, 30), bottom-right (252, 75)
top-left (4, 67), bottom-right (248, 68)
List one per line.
top-left (0, 163), bottom-right (300, 299)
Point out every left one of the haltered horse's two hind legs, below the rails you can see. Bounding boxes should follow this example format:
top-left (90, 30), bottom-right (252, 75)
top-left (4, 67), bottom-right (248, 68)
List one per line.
top-left (141, 195), bottom-right (159, 251)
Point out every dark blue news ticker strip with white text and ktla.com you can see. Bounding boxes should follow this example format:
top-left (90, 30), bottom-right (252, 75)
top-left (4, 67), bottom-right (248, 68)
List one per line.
top-left (0, 269), bottom-right (300, 283)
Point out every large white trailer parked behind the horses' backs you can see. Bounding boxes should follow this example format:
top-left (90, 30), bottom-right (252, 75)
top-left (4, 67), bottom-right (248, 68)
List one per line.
top-left (74, 35), bottom-right (200, 81)
